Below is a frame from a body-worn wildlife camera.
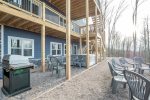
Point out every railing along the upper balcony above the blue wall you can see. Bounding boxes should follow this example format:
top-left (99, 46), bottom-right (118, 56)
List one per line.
top-left (2, 0), bottom-right (80, 33)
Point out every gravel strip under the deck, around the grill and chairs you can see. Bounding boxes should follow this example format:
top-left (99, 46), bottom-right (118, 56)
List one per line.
top-left (0, 67), bottom-right (86, 100)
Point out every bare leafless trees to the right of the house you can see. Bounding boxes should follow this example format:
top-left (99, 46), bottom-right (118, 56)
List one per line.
top-left (104, 0), bottom-right (150, 62)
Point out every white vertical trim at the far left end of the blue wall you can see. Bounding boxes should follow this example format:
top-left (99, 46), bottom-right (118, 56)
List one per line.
top-left (0, 24), bottom-right (4, 61)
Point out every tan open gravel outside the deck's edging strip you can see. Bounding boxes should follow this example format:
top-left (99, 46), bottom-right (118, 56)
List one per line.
top-left (36, 60), bottom-right (150, 100)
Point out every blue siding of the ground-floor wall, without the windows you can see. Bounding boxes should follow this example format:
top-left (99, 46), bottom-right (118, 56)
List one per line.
top-left (4, 26), bottom-right (79, 58)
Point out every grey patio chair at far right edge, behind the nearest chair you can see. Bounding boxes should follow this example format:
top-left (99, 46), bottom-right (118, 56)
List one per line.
top-left (133, 57), bottom-right (150, 74)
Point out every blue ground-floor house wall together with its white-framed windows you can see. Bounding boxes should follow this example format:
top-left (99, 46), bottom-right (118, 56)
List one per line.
top-left (1, 25), bottom-right (79, 59)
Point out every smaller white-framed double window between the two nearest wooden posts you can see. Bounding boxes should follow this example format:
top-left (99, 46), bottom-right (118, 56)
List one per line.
top-left (51, 42), bottom-right (62, 56)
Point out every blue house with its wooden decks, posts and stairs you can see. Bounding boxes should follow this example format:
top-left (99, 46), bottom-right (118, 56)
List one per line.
top-left (0, 0), bottom-right (105, 78)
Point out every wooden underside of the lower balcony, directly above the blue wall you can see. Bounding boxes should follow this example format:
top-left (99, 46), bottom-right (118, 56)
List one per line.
top-left (0, 12), bottom-right (79, 40)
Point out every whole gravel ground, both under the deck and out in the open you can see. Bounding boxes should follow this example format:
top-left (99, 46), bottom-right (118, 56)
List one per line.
top-left (0, 59), bottom-right (150, 100)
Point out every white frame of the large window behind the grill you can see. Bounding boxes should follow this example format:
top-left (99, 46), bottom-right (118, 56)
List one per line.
top-left (8, 36), bottom-right (34, 58)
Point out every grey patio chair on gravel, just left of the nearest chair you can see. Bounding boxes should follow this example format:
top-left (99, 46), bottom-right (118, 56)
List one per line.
top-left (108, 61), bottom-right (127, 94)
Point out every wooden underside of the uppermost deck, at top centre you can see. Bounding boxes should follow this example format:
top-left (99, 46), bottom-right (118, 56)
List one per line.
top-left (49, 0), bottom-right (98, 20)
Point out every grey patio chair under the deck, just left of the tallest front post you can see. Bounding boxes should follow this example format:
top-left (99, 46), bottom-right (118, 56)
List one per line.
top-left (50, 56), bottom-right (66, 77)
